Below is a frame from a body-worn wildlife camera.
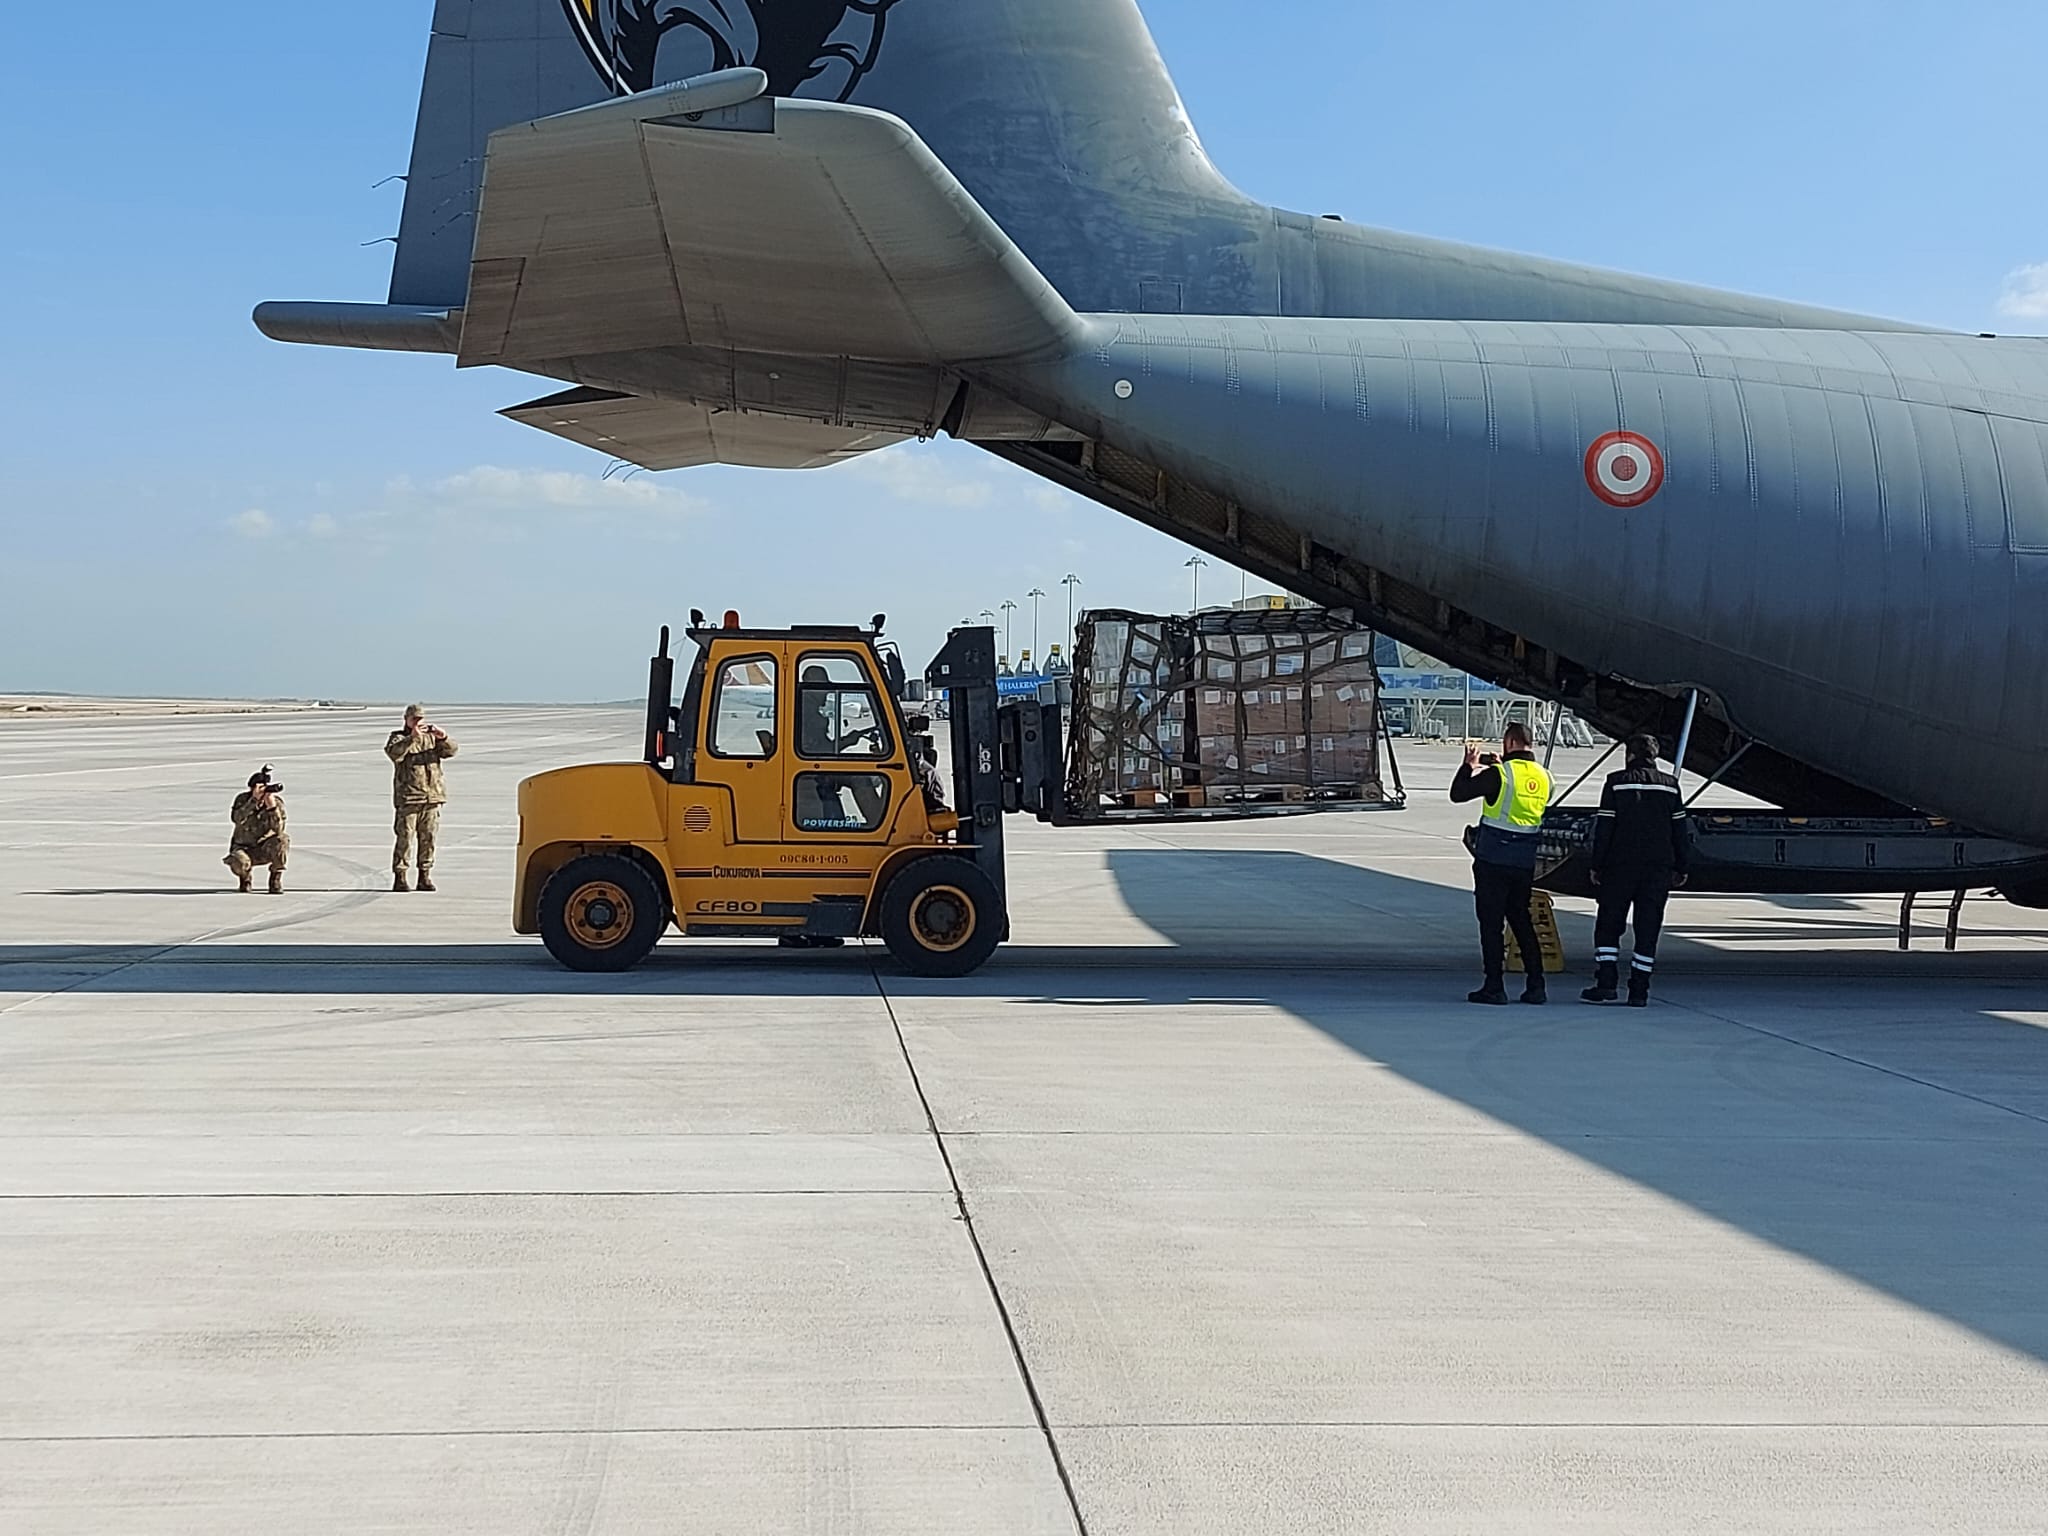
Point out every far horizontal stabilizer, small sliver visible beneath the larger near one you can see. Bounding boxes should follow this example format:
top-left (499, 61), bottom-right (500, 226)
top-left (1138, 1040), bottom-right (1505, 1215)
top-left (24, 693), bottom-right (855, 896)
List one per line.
top-left (502, 389), bottom-right (903, 469)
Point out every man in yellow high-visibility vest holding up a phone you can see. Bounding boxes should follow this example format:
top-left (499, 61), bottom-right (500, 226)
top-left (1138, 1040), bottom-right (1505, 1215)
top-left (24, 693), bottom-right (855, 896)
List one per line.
top-left (1450, 725), bottom-right (1550, 1004)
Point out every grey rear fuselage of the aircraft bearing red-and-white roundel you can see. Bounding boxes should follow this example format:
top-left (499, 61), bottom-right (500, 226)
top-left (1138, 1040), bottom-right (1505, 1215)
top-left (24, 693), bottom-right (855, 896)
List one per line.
top-left (983, 315), bottom-right (2048, 844)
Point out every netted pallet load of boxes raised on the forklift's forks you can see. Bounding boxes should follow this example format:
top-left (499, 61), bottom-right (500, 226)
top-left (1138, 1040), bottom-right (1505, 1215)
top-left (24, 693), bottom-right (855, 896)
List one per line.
top-left (1067, 608), bottom-right (1386, 817)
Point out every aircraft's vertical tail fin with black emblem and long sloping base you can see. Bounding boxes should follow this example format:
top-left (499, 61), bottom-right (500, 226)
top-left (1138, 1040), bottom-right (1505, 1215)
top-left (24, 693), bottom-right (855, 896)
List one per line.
top-left (372, 0), bottom-right (1890, 342)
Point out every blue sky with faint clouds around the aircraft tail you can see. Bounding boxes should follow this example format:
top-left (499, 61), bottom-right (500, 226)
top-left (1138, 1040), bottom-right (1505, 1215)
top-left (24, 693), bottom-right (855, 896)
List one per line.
top-left (0, 0), bottom-right (2048, 700)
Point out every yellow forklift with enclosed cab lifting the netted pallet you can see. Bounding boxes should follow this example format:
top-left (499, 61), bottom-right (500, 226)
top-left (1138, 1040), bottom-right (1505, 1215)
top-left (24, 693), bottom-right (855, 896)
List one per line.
top-left (512, 612), bottom-right (1065, 977)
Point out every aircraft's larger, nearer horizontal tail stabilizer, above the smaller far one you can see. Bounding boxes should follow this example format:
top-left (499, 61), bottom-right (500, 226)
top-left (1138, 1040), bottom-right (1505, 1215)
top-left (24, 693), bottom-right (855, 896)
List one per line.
top-left (461, 92), bottom-right (1077, 367)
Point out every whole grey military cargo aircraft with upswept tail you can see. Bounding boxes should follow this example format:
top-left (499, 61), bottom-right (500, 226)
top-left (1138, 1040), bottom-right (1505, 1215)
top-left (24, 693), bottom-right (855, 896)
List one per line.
top-left (258, 0), bottom-right (2048, 901)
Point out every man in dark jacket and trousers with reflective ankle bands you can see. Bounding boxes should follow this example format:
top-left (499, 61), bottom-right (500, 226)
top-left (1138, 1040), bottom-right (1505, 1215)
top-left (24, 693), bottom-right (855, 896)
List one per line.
top-left (1579, 735), bottom-right (1692, 1008)
